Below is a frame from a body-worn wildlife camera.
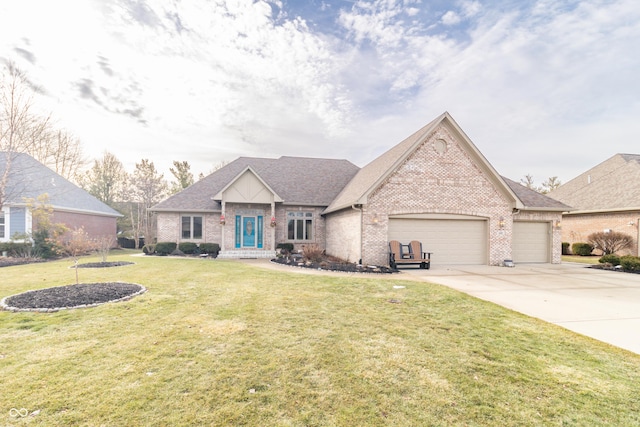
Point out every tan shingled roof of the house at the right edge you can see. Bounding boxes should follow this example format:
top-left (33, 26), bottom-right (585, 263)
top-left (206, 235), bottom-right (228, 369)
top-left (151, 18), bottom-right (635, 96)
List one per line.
top-left (549, 153), bottom-right (640, 213)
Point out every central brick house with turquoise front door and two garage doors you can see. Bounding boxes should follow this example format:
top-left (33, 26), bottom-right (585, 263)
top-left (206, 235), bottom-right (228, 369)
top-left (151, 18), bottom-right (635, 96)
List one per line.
top-left (152, 113), bottom-right (569, 265)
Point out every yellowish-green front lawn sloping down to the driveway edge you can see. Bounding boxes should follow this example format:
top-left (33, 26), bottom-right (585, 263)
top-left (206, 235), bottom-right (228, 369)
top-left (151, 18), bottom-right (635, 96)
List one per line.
top-left (0, 253), bottom-right (640, 426)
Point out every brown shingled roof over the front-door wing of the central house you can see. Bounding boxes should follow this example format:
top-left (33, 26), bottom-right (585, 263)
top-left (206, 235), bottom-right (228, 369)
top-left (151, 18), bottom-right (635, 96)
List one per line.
top-left (152, 156), bottom-right (359, 212)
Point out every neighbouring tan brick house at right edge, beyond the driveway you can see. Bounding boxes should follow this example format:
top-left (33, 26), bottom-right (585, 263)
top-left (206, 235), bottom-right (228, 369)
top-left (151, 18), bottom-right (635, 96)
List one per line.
top-left (548, 154), bottom-right (640, 255)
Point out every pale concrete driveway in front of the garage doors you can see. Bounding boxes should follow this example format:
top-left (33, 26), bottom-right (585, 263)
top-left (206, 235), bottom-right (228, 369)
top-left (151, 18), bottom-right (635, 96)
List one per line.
top-left (396, 263), bottom-right (640, 354)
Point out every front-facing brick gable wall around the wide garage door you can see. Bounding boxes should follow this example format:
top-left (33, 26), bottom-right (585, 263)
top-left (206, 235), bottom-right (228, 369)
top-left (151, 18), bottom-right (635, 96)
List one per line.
top-left (362, 122), bottom-right (512, 265)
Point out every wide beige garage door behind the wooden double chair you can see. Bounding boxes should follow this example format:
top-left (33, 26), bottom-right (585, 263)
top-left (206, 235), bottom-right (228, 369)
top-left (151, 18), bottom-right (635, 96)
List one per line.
top-left (389, 218), bottom-right (488, 265)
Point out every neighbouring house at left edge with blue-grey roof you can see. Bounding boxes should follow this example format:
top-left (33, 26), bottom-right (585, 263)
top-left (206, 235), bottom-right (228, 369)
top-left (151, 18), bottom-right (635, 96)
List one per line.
top-left (0, 152), bottom-right (122, 242)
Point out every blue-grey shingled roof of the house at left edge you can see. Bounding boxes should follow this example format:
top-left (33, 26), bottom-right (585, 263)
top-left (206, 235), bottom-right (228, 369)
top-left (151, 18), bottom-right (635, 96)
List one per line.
top-left (0, 152), bottom-right (122, 217)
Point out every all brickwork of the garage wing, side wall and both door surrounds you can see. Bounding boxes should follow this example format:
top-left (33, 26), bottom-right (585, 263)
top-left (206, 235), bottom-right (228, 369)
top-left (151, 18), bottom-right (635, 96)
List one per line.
top-left (327, 125), bottom-right (561, 265)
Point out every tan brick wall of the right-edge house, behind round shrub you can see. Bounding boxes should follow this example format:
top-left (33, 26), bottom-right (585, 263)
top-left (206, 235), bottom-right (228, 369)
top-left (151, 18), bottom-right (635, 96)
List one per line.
top-left (562, 211), bottom-right (640, 256)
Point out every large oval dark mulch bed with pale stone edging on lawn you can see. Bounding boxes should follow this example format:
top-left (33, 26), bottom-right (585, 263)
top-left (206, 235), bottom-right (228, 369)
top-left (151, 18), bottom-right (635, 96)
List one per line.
top-left (0, 282), bottom-right (146, 312)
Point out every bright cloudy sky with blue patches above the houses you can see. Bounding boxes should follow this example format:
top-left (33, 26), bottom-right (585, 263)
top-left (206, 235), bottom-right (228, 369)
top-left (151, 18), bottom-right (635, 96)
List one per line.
top-left (0, 0), bottom-right (640, 184)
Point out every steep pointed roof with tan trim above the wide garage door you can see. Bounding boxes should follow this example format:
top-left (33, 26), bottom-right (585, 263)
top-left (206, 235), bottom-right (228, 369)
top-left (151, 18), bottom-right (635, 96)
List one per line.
top-left (325, 112), bottom-right (525, 213)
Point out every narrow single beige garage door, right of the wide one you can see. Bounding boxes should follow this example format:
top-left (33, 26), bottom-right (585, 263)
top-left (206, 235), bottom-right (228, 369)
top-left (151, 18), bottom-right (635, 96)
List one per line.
top-left (512, 221), bottom-right (550, 263)
